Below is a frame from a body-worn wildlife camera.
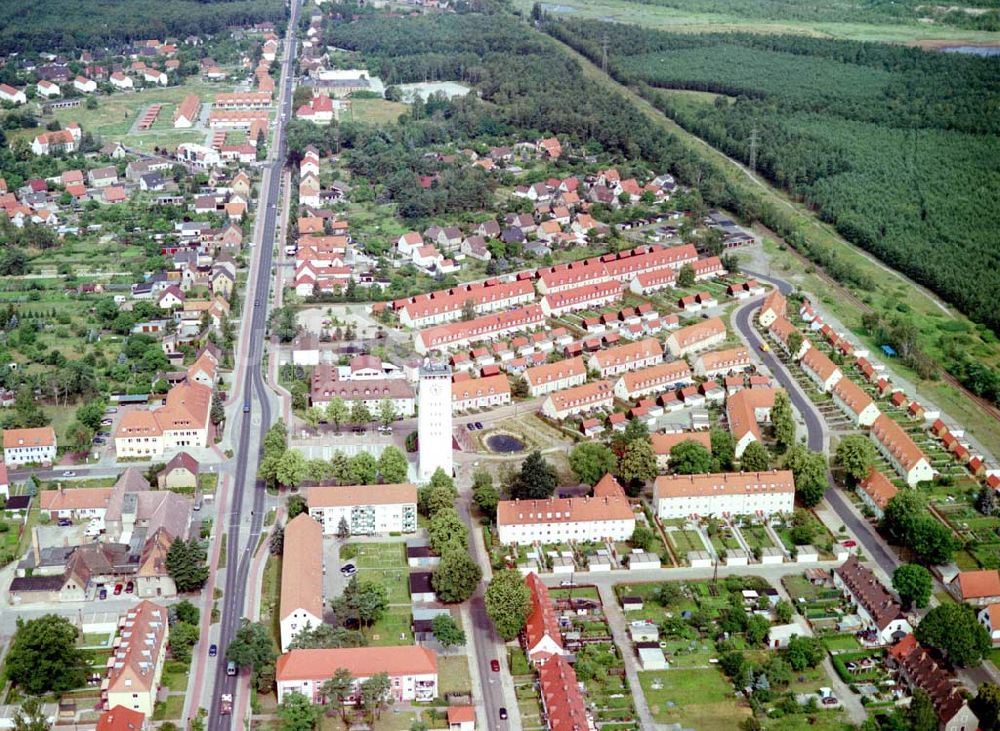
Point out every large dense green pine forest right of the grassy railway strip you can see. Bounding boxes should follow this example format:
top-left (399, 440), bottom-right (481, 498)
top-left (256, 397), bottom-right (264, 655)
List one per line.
top-left (546, 21), bottom-right (1000, 332)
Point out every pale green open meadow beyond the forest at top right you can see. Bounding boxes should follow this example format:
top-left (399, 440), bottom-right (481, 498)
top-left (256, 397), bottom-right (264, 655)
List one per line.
top-left (514, 0), bottom-right (998, 43)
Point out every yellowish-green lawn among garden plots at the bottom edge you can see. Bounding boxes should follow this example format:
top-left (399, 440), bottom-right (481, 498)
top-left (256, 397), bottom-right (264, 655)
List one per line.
top-left (639, 668), bottom-right (750, 731)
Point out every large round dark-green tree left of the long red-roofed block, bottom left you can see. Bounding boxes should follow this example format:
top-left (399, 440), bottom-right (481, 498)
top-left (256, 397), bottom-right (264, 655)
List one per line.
top-left (4, 614), bottom-right (90, 695)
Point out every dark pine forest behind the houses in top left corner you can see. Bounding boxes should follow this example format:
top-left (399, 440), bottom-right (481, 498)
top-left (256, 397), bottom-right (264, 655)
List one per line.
top-left (0, 0), bottom-right (287, 53)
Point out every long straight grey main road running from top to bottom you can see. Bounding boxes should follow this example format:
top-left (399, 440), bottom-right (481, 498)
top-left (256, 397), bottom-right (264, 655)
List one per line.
top-left (208, 0), bottom-right (300, 731)
